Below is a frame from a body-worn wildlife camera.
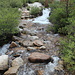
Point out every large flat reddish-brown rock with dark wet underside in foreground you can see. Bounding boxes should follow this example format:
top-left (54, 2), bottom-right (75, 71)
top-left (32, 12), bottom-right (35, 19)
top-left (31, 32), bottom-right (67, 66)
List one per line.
top-left (28, 52), bottom-right (51, 63)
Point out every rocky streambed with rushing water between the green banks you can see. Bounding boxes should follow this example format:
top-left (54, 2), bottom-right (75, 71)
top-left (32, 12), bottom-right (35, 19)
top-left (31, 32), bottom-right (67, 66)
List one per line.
top-left (0, 2), bottom-right (64, 75)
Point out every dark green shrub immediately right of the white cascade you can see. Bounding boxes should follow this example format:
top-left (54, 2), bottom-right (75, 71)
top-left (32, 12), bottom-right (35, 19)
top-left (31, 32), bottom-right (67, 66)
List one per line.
top-left (48, 8), bottom-right (69, 34)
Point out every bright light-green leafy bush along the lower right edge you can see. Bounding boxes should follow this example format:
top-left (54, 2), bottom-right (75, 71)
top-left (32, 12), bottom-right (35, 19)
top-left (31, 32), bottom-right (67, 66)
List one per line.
top-left (61, 35), bottom-right (75, 73)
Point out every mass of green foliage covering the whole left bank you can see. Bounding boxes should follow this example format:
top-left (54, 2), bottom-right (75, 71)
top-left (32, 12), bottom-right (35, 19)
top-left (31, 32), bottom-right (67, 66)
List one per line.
top-left (0, 0), bottom-right (20, 45)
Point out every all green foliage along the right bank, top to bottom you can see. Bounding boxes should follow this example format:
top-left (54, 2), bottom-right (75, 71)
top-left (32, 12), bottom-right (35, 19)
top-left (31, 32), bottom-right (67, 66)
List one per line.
top-left (47, 0), bottom-right (75, 73)
